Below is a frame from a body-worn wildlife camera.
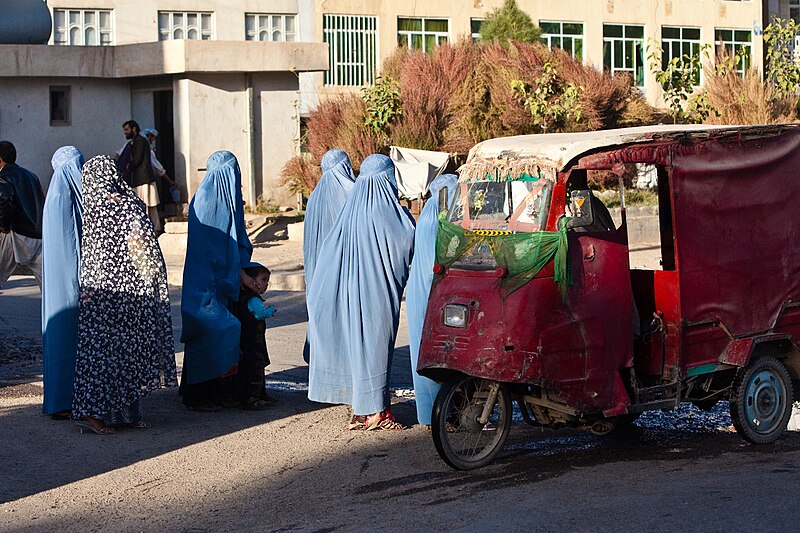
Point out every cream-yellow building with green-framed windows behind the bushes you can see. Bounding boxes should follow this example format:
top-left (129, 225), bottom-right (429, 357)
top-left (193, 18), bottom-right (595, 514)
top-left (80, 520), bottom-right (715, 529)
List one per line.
top-left (314, 0), bottom-right (776, 105)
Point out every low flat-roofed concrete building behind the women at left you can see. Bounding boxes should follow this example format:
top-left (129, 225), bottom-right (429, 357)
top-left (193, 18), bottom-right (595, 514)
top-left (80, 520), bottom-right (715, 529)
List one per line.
top-left (0, 40), bottom-right (327, 203)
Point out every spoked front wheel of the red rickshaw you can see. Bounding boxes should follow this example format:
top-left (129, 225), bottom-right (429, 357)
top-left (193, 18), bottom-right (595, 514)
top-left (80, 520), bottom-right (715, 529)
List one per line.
top-left (431, 376), bottom-right (511, 470)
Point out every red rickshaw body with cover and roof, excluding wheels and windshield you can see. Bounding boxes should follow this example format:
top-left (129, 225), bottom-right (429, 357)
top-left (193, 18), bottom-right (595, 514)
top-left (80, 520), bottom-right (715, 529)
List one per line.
top-left (418, 126), bottom-right (800, 427)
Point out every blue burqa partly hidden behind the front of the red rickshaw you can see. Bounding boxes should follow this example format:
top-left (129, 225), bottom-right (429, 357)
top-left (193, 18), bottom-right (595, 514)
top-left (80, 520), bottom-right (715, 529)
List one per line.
top-left (406, 174), bottom-right (458, 425)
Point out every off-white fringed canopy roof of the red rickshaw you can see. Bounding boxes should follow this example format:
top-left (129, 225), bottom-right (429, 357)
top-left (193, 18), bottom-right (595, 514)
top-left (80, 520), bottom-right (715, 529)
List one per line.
top-left (459, 124), bottom-right (788, 182)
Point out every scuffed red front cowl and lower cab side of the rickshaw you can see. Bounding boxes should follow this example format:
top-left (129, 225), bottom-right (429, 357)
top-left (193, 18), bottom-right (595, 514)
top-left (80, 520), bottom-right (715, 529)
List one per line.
top-left (417, 228), bottom-right (633, 413)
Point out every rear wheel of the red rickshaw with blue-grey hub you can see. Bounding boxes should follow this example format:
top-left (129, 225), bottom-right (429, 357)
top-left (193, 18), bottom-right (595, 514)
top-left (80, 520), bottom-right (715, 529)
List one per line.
top-left (730, 356), bottom-right (794, 444)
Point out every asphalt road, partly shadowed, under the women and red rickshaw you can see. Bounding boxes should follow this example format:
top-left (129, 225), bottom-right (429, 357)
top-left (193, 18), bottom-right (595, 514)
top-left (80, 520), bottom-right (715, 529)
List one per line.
top-left (0, 246), bottom-right (800, 532)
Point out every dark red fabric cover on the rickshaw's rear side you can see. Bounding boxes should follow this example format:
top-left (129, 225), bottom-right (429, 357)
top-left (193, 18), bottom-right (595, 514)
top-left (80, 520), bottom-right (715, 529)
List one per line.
top-left (672, 130), bottom-right (800, 368)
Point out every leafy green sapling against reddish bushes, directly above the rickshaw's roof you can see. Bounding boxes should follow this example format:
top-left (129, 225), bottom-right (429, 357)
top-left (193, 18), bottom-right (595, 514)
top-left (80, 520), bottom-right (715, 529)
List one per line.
top-left (511, 62), bottom-right (583, 133)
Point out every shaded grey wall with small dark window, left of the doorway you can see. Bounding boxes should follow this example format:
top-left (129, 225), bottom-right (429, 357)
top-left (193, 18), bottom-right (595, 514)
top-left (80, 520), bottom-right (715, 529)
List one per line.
top-left (0, 77), bottom-right (131, 188)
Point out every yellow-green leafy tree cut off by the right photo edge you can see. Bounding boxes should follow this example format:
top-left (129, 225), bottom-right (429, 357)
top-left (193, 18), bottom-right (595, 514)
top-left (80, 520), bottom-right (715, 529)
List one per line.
top-left (764, 17), bottom-right (800, 98)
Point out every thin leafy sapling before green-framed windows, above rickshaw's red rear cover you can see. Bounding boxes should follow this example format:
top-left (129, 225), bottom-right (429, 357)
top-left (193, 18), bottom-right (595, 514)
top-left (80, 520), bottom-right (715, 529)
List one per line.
top-left (647, 41), bottom-right (716, 123)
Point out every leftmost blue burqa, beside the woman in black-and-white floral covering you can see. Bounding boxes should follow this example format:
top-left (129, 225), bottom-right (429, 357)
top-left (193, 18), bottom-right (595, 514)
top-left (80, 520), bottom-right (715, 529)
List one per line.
top-left (42, 146), bottom-right (84, 414)
